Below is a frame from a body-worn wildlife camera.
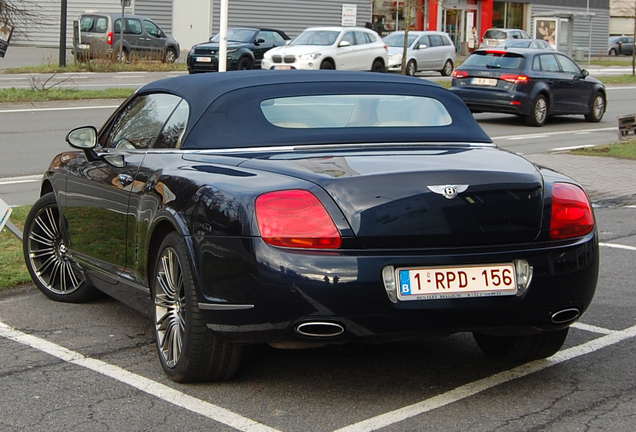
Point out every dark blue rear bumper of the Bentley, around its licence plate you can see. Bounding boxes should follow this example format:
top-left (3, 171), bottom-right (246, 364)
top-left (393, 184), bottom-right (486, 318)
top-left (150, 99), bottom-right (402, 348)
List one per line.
top-left (189, 232), bottom-right (599, 343)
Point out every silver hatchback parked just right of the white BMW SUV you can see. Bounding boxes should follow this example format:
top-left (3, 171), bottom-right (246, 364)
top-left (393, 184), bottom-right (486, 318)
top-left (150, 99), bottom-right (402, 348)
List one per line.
top-left (384, 31), bottom-right (456, 76)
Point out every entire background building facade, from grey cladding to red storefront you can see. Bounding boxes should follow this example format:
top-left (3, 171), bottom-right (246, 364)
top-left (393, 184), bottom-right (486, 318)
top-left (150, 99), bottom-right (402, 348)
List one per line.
top-left (12, 0), bottom-right (612, 56)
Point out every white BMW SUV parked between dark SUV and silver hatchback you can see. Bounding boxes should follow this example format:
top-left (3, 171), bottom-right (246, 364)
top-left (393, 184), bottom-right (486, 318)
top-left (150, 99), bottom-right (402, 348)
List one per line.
top-left (261, 27), bottom-right (388, 72)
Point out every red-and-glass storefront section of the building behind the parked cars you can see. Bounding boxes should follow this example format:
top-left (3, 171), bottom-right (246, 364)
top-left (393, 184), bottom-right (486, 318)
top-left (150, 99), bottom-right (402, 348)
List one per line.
top-left (372, 0), bottom-right (610, 56)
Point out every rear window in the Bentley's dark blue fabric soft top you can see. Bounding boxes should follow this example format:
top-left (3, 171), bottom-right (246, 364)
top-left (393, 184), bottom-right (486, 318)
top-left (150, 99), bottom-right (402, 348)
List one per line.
top-left (261, 94), bottom-right (452, 128)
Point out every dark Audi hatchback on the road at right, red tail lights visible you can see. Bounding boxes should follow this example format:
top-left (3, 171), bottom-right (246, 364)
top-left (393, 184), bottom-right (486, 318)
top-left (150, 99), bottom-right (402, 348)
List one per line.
top-left (451, 48), bottom-right (607, 126)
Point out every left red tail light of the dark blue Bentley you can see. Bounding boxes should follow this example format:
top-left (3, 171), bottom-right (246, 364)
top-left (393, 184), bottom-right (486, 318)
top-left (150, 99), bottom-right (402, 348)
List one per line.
top-left (256, 190), bottom-right (342, 249)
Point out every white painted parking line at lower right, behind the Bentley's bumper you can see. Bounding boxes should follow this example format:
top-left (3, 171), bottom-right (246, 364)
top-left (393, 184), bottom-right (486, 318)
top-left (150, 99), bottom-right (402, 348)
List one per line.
top-left (334, 326), bottom-right (636, 432)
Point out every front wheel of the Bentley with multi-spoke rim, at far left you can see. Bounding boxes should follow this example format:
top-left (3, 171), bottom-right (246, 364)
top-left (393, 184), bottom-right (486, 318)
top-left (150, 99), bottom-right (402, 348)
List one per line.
top-left (23, 192), bottom-right (101, 303)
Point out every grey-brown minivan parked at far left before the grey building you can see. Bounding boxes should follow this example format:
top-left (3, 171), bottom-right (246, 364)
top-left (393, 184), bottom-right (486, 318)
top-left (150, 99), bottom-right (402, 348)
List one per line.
top-left (74, 13), bottom-right (181, 63)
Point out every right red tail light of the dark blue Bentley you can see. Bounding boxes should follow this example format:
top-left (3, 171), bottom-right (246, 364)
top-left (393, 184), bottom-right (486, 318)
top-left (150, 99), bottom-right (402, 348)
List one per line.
top-left (550, 183), bottom-right (594, 240)
